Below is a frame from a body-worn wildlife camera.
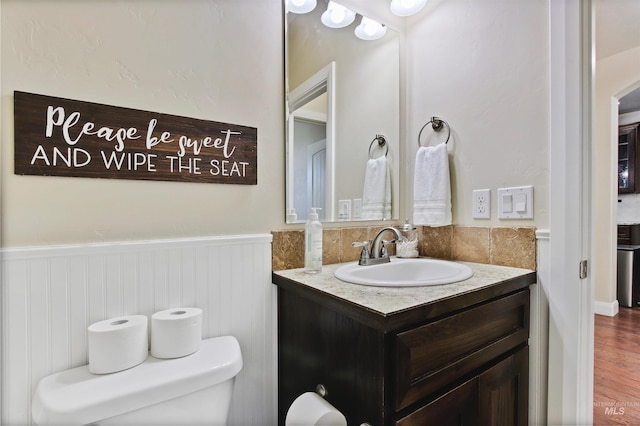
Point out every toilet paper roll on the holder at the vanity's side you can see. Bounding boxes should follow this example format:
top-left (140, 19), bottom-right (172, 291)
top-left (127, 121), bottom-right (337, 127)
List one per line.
top-left (284, 392), bottom-right (347, 426)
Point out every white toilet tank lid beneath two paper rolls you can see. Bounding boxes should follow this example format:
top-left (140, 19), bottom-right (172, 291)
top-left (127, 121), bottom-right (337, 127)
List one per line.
top-left (31, 336), bottom-right (242, 425)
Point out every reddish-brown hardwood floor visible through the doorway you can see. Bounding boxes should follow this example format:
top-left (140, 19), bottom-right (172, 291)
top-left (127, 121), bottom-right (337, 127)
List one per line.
top-left (593, 307), bottom-right (640, 425)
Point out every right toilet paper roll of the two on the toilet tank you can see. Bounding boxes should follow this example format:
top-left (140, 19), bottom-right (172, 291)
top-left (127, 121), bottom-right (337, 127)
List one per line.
top-left (151, 308), bottom-right (202, 358)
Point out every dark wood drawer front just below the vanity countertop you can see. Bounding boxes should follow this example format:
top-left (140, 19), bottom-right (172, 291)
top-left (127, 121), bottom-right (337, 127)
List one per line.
top-left (394, 289), bottom-right (529, 410)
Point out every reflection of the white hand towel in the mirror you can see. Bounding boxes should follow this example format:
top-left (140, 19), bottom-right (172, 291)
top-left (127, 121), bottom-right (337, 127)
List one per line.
top-left (361, 156), bottom-right (391, 220)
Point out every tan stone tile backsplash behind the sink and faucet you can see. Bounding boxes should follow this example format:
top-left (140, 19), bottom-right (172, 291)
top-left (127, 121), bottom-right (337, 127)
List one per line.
top-left (272, 226), bottom-right (536, 271)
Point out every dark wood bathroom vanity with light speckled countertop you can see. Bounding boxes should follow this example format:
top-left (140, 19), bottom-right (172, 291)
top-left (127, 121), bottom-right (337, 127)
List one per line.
top-left (273, 260), bottom-right (536, 426)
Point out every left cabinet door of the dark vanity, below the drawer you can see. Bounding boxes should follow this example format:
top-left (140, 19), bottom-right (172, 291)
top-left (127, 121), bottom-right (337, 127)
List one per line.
top-left (395, 377), bottom-right (481, 426)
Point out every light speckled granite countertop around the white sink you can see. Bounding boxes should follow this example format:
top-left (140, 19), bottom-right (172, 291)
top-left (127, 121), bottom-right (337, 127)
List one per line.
top-left (273, 259), bottom-right (535, 316)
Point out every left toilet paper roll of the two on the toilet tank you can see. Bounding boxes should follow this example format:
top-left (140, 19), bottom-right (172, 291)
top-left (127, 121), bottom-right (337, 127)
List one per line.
top-left (87, 315), bottom-right (149, 374)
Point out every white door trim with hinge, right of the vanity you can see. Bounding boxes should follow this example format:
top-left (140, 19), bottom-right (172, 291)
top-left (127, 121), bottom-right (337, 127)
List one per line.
top-left (546, 0), bottom-right (594, 424)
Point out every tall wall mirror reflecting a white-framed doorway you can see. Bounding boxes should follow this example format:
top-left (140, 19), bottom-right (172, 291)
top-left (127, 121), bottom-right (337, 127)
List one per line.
top-left (285, 1), bottom-right (400, 223)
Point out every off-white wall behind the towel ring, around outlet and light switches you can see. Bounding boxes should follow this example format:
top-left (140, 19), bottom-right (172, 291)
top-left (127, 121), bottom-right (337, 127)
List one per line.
top-left (406, 0), bottom-right (549, 228)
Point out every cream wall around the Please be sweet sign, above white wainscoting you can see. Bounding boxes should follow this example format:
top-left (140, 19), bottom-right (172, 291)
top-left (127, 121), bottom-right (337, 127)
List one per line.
top-left (0, 0), bottom-right (284, 247)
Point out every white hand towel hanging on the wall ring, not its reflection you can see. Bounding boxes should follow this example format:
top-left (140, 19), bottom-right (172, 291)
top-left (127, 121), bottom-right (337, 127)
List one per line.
top-left (413, 143), bottom-right (452, 226)
